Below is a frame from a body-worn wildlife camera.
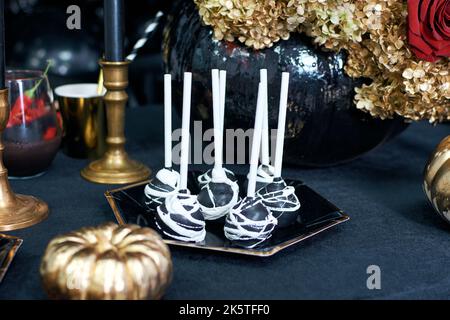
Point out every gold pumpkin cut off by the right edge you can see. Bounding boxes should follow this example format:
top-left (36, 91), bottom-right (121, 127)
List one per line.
top-left (423, 136), bottom-right (450, 223)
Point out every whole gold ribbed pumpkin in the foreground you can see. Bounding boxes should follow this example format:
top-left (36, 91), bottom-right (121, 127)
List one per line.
top-left (40, 223), bottom-right (172, 300)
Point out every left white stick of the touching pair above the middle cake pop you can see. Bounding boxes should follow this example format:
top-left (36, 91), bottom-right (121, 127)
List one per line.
top-left (211, 69), bottom-right (223, 170)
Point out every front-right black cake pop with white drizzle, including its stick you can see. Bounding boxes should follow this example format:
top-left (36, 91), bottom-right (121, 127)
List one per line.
top-left (224, 84), bottom-right (278, 248)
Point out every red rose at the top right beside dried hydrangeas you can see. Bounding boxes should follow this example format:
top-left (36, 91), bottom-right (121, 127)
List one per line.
top-left (408, 0), bottom-right (450, 62)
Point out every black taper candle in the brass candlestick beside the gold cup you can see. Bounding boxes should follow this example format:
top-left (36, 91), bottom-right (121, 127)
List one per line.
top-left (104, 0), bottom-right (124, 61)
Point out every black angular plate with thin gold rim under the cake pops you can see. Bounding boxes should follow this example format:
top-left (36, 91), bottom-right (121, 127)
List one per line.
top-left (105, 172), bottom-right (349, 256)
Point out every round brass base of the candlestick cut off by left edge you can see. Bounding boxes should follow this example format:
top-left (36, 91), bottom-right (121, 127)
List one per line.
top-left (0, 194), bottom-right (48, 231)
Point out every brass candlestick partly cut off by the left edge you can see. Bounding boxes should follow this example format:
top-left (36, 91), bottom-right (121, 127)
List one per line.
top-left (0, 89), bottom-right (48, 231)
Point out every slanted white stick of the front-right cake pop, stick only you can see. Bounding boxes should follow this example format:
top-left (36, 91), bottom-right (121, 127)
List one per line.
top-left (247, 83), bottom-right (264, 197)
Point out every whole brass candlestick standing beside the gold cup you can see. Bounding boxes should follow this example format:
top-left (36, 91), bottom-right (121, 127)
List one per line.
top-left (81, 60), bottom-right (151, 184)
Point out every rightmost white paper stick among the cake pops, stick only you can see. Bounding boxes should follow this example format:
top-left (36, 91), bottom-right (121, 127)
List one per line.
top-left (275, 72), bottom-right (289, 177)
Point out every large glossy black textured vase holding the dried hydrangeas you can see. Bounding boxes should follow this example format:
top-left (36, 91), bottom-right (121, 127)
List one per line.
top-left (163, 1), bottom-right (406, 166)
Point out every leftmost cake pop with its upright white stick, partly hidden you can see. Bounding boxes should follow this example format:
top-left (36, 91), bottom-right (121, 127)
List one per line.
top-left (144, 74), bottom-right (180, 211)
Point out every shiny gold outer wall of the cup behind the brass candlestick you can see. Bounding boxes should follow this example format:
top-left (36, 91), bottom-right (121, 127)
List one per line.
top-left (58, 89), bottom-right (106, 159)
